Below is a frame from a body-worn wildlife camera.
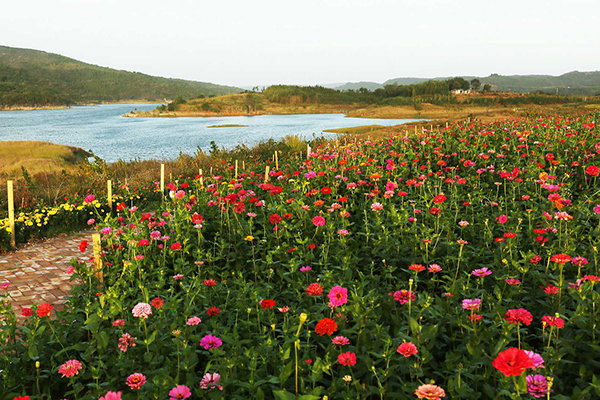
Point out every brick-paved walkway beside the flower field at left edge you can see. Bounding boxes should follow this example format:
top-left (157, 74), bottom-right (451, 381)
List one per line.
top-left (0, 231), bottom-right (93, 320)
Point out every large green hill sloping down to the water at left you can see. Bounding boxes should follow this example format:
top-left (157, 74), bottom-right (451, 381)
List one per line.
top-left (0, 46), bottom-right (242, 108)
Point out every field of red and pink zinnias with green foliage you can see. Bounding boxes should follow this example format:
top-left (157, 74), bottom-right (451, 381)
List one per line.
top-left (0, 113), bottom-right (600, 400)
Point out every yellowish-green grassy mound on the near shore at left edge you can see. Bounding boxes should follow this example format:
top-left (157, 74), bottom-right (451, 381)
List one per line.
top-left (0, 141), bottom-right (89, 180)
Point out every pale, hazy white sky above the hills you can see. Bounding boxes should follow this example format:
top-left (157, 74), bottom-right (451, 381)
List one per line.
top-left (0, 0), bottom-right (600, 86)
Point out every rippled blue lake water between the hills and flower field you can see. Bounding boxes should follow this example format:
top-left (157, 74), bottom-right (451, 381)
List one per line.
top-left (0, 104), bottom-right (417, 161)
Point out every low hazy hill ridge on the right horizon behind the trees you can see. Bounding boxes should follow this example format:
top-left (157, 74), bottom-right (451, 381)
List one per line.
top-left (335, 71), bottom-right (600, 96)
